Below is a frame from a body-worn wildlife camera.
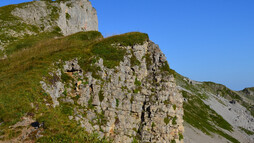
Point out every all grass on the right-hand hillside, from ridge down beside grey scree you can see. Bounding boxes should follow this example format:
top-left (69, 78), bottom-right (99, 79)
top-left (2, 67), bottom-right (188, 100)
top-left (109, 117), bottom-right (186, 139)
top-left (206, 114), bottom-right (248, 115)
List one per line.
top-left (171, 70), bottom-right (239, 143)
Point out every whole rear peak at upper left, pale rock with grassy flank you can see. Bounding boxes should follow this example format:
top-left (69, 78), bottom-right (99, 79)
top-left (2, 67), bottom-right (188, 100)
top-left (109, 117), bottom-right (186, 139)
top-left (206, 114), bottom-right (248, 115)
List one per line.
top-left (0, 0), bottom-right (98, 58)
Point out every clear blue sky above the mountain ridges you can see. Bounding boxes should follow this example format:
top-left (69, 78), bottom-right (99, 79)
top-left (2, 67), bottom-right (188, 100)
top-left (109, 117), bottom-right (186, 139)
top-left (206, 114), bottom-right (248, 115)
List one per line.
top-left (0, 0), bottom-right (254, 90)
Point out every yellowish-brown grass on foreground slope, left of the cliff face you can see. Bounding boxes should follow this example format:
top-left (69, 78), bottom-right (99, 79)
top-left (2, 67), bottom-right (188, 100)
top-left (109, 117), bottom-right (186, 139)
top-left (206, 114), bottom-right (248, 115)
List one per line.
top-left (0, 32), bottom-right (102, 139)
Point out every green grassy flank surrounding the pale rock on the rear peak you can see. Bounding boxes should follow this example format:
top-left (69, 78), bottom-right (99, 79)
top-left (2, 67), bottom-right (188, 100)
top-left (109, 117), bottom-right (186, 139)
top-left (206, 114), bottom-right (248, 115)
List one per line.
top-left (0, 0), bottom-right (64, 57)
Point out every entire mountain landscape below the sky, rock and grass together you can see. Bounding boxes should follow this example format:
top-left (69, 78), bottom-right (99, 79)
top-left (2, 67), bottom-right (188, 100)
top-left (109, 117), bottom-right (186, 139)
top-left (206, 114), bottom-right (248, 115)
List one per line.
top-left (0, 0), bottom-right (254, 143)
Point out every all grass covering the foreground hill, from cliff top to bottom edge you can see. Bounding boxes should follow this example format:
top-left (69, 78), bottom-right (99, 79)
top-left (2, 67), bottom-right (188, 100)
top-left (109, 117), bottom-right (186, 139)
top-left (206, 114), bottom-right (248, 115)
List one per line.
top-left (0, 32), bottom-right (148, 142)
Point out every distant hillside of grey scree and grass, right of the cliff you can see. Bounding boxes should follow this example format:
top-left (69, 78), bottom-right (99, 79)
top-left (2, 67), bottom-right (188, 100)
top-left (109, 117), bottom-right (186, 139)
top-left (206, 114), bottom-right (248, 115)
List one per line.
top-left (171, 70), bottom-right (254, 143)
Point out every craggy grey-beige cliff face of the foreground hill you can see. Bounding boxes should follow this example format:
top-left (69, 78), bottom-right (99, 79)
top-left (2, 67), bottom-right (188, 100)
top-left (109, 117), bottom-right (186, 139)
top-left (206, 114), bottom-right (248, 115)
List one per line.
top-left (41, 41), bottom-right (184, 143)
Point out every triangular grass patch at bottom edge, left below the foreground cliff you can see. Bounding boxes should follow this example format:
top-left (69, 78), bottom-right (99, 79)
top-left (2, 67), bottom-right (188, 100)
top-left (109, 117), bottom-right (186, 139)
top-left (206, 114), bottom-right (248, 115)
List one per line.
top-left (37, 107), bottom-right (109, 143)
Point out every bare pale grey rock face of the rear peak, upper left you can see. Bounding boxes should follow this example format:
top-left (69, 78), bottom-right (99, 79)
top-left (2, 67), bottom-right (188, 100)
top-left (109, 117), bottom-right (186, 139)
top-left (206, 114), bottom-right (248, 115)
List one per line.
top-left (12, 0), bottom-right (98, 35)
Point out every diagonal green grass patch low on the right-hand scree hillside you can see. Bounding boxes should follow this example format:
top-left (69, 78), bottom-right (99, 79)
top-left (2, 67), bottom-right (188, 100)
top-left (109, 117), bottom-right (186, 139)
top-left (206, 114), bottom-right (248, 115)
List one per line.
top-left (182, 91), bottom-right (239, 143)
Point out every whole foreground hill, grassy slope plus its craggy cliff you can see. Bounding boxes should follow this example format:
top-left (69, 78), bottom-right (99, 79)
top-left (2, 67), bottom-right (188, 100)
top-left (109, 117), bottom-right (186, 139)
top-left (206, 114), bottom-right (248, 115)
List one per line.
top-left (0, 31), bottom-right (183, 142)
